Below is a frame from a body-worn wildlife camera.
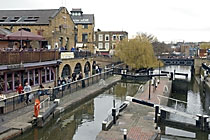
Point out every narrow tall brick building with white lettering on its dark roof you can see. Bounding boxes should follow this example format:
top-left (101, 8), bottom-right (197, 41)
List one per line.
top-left (71, 9), bottom-right (95, 52)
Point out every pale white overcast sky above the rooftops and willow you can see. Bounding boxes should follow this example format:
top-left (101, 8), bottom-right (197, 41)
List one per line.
top-left (0, 0), bottom-right (210, 42)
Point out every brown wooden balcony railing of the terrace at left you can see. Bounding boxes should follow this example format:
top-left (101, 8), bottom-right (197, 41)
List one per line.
top-left (0, 50), bottom-right (60, 65)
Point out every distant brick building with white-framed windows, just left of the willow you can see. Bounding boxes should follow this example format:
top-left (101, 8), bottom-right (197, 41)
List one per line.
top-left (94, 30), bottom-right (128, 55)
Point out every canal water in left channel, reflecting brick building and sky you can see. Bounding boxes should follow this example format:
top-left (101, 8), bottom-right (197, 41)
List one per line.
top-left (15, 82), bottom-right (140, 140)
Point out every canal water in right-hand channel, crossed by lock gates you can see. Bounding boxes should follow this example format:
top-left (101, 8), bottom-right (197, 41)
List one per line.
top-left (156, 66), bottom-right (210, 140)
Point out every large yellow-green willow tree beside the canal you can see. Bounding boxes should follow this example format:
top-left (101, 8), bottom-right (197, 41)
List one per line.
top-left (115, 34), bottom-right (163, 69)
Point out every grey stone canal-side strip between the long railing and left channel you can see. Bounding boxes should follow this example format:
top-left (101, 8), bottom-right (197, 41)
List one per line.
top-left (0, 76), bottom-right (121, 140)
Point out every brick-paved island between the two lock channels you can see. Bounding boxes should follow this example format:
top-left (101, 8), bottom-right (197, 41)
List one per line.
top-left (96, 78), bottom-right (171, 140)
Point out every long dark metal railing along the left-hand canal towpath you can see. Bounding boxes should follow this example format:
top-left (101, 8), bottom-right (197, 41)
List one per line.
top-left (0, 70), bottom-right (112, 114)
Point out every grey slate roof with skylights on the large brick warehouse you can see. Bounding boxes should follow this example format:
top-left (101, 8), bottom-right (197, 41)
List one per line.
top-left (0, 7), bottom-right (62, 25)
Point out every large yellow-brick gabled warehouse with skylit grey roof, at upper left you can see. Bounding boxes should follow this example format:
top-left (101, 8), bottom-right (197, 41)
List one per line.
top-left (0, 7), bottom-right (75, 50)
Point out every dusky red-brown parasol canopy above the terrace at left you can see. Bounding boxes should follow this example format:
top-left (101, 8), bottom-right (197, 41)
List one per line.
top-left (5, 30), bottom-right (44, 40)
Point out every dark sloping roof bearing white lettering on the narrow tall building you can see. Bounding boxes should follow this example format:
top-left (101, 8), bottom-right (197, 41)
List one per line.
top-left (71, 14), bottom-right (94, 24)
